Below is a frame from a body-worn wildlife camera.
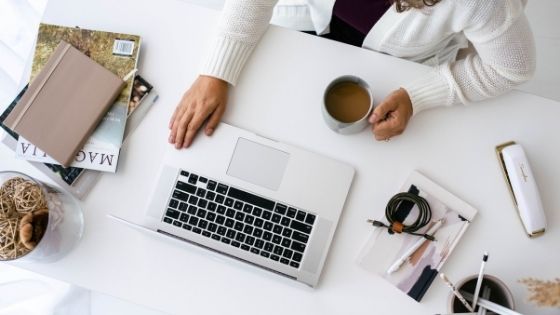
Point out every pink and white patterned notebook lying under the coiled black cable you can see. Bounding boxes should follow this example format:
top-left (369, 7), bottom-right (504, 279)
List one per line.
top-left (357, 172), bottom-right (477, 302)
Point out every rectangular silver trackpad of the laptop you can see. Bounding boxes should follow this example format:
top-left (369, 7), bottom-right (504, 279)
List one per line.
top-left (227, 138), bottom-right (290, 190)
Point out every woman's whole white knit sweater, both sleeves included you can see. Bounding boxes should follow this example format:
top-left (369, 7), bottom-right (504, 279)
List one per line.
top-left (201, 0), bottom-right (536, 114)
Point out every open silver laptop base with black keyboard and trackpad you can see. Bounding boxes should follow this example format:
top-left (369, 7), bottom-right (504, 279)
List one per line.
top-left (140, 124), bottom-right (354, 286)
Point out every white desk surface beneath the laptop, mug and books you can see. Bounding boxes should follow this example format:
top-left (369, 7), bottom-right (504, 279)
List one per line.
top-left (0, 0), bottom-right (560, 314)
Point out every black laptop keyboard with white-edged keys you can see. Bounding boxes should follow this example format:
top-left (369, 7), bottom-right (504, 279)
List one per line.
top-left (163, 171), bottom-right (315, 268)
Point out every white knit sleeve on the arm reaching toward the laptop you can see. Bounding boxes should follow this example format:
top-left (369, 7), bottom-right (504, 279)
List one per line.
top-left (200, 0), bottom-right (278, 85)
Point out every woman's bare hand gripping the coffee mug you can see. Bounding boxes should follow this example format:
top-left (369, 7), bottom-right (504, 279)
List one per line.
top-left (369, 88), bottom-right (412, 141)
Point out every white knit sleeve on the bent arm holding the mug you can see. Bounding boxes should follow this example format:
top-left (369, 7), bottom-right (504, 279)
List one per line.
top-left (403, 0), bottom-right (536, 114)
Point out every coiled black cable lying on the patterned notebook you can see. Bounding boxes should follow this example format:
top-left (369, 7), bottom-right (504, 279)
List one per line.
top-left (368, 192), bottom-right (435, 241)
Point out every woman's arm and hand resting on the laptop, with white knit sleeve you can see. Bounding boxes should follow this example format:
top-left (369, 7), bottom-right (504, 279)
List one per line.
top-left (169, 0), bottom-right (278, 149)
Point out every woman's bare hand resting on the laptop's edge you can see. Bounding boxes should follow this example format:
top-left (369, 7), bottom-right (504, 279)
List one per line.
top-left (169, 76), bottom-right (229, 149)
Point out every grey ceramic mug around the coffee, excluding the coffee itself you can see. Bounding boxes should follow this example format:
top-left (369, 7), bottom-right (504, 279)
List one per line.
top-left (321, 75), bottom-right (374, 135)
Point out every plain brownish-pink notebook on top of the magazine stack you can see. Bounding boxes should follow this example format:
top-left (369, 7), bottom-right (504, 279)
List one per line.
top-left (4, 41), bottom-right (125, 167)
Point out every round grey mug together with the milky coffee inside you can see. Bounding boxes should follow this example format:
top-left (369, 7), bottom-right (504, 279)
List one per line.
top-left (323, 75), bottom-right (373, 134)
